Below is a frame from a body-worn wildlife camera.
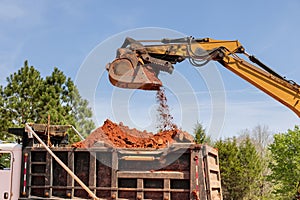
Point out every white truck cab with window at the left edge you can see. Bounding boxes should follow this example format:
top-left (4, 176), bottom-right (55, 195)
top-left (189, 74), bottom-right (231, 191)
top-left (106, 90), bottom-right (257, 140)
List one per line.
top-left (0, 143), bottom-right (22, 200)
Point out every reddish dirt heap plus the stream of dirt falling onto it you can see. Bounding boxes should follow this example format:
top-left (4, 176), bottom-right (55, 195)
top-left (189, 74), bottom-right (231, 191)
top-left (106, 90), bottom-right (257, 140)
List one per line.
top-left (72, 87), bottom-right (194, 149)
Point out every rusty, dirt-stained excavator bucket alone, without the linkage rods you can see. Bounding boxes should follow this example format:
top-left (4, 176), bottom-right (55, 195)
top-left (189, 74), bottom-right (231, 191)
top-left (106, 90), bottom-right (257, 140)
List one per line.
top-left (106, 48), bottom-right (162, 90)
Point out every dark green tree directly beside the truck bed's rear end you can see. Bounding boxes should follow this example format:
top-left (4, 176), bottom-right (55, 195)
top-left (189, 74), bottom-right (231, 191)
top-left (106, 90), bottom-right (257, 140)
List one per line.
top-left (215, 137), bottom-right (262, 200)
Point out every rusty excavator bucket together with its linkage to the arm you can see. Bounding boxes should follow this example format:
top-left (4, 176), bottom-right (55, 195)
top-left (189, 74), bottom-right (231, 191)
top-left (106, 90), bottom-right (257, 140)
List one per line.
top-left (106, 38), bottom-right (174, 90)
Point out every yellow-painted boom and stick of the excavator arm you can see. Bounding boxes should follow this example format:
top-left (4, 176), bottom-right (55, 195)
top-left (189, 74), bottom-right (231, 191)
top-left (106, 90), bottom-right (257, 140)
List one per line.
top-left (145, 38), bottom-right (300, 117)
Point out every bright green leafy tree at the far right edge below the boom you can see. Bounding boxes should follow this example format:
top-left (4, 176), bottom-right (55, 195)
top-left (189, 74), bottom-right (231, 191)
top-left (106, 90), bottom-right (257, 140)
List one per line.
top-left (268, 126), bottom-right (300, 199)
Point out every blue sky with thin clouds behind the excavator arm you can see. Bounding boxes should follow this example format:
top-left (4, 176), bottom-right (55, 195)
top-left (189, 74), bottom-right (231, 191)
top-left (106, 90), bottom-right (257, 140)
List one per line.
top-left (0, 0), bottom-right (300, 137)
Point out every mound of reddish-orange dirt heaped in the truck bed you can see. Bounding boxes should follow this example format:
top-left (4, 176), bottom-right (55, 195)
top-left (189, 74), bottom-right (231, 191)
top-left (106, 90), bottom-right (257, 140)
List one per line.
top-left (72, 119), bottom-right (194, 148)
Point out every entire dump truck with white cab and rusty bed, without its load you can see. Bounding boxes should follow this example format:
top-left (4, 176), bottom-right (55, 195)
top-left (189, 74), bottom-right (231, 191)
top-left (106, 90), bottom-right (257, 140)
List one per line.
top-left (0, 124), bottom-right (222, 200)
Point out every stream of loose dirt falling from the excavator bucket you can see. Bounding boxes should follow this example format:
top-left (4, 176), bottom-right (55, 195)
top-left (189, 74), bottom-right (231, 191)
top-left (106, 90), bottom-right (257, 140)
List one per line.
top-left (156, 87), bottom-right (177, 131)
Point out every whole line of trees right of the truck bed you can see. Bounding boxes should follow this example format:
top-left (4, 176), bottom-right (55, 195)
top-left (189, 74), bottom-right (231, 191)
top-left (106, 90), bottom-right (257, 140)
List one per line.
top-left (195, 124), bottom-right (300, 200)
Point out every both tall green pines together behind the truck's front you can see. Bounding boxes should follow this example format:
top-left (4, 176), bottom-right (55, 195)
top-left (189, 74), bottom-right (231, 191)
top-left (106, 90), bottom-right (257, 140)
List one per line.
top-left (0, 61), bottom-right (95, 142)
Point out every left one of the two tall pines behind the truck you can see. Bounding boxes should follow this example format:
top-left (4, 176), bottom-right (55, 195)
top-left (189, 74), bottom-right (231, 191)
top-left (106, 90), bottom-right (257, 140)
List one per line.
top-left (2, 61), bottom-right (42, 126)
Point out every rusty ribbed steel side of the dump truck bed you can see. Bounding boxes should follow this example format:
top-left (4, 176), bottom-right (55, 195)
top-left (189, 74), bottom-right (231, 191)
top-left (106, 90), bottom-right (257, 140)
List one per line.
top-left (20, 144), bottom-right (222, 200)
